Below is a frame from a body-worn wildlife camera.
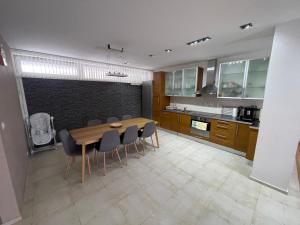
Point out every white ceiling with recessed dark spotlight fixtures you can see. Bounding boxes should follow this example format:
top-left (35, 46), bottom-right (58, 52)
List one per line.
top-left (0, 0), bottom-right (300, 70)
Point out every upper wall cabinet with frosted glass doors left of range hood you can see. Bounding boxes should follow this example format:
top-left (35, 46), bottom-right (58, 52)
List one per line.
top-left (165, 67), bottom-right (203, 97)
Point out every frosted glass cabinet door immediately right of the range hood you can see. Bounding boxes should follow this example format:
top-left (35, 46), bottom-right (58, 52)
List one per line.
top-left (218, 60), bottom-right (246, 98)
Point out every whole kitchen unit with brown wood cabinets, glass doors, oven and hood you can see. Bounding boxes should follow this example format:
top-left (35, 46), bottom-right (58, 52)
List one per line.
top-left (153, 56), bottom-right (269, 161)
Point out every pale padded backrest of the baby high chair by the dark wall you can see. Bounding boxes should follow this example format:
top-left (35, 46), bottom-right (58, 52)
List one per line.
top-left (29, 113), bottom-right (53, 145)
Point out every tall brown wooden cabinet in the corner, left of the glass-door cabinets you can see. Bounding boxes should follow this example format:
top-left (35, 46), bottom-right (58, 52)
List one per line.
top-left (152, 72), bottom-right (170, 125)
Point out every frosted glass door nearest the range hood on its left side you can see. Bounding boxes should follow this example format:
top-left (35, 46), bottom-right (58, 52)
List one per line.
top-left (182, 68), bottom-right (197, 97)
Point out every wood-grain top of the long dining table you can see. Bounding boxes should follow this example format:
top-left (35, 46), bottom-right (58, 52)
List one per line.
top-left (70, 117), bottom-right (157, 145)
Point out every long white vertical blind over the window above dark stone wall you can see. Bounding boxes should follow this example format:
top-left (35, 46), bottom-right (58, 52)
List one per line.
top-left (13, 51), bottom-right (153, 84)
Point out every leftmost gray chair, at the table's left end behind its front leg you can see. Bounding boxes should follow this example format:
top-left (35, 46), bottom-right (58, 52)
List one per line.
top-left (58, 129), bottom-right (94, 176)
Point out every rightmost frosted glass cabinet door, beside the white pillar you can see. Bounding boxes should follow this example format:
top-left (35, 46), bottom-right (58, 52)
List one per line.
top-left (245, 58), bottom-right (269, 98)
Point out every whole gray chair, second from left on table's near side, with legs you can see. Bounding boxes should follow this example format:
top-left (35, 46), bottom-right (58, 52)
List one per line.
top-left (96, 130), bottom-right (122, 175)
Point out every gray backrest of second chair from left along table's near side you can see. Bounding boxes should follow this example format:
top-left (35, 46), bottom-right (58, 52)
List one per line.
top-left (100, 130), bottom-right (121, 152)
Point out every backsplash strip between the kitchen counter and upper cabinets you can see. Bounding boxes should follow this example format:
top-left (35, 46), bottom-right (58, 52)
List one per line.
top-left (171, 96), bottom-right (263, 110)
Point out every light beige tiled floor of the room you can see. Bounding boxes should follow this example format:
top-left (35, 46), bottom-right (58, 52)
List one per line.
top-left (19, 131), bottom-right (300, 225)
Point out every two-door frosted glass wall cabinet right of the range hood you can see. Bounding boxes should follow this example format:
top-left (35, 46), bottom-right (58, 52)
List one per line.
top-left (218, 58), bottom-right (269, 99)
